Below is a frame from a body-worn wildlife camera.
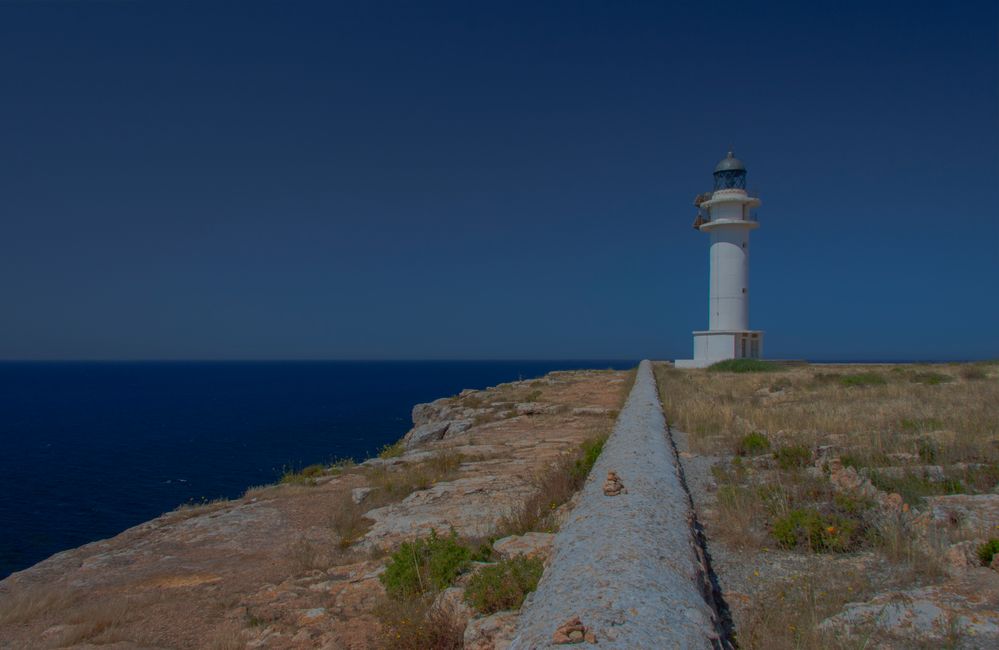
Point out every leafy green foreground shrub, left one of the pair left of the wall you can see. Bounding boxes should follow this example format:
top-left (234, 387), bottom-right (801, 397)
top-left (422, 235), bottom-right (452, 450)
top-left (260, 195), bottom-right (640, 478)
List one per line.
top-left (378, 530), bottom-right (472, 598)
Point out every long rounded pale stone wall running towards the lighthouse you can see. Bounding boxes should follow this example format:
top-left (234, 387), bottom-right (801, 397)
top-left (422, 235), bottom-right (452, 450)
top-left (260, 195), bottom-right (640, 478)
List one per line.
top-left (510, 361), bottom-right (730, 650)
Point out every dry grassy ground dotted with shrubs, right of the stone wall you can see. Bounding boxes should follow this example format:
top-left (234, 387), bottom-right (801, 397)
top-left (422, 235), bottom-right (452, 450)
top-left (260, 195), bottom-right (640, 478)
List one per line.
top-left (656, 363), bottom-right (999, 649)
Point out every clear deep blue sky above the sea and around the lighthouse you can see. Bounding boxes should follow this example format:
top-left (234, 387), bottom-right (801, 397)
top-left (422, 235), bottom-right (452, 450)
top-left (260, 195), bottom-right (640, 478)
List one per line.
top-left (0, 0), bottom-right (999, 359)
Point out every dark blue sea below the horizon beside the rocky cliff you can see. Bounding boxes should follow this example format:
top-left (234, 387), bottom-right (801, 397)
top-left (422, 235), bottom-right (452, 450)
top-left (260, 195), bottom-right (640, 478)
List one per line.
top-left (0, 361), bottom-right (634, 578)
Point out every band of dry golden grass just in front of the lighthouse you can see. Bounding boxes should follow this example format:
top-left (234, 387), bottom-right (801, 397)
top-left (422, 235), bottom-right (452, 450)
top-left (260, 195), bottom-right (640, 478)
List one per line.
top-left (656, 364), bottom-right (999, 464)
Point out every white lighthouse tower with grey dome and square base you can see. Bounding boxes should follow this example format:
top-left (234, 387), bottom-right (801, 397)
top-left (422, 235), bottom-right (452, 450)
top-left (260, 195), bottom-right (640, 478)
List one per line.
top-left (676, 151), bottom-right (763, 368)
